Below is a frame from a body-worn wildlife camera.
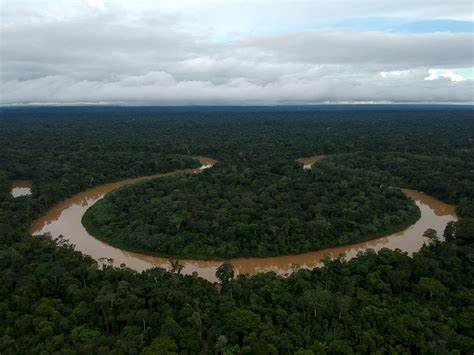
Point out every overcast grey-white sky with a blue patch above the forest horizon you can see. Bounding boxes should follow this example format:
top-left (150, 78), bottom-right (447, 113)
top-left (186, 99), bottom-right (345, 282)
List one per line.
top-left (0, 0), bottom-right (474, 105)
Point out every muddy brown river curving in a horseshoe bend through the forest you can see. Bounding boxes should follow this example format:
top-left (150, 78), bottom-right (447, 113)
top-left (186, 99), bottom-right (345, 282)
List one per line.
top-left (30, 157), bottom-right (457, 282)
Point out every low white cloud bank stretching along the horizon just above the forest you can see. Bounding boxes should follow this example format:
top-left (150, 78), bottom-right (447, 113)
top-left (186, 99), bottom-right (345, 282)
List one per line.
top-left (1, 68), bottom-right (472, 104)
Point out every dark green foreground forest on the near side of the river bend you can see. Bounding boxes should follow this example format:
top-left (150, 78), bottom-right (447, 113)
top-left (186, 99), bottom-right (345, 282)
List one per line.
top-left (0, 223), bottom-right (474, 353)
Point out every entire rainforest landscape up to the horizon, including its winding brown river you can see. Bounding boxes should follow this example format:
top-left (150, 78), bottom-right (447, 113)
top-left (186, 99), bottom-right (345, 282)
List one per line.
top-left (0, 105), bottom-right (474, 354)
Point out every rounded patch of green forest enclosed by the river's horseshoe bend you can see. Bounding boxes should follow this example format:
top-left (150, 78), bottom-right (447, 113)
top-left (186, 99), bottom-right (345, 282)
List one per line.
top-left (83, 158), bottom-right (419, 258)
